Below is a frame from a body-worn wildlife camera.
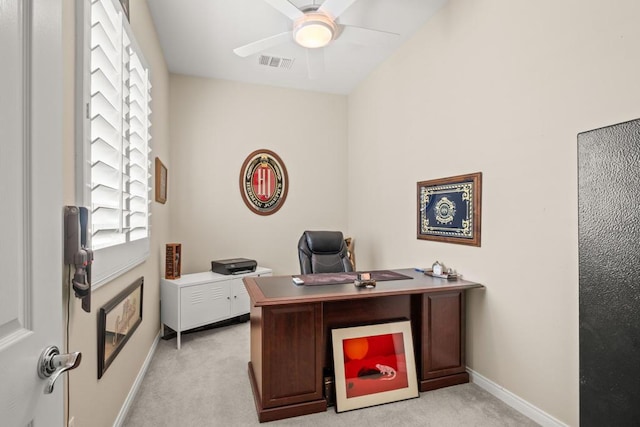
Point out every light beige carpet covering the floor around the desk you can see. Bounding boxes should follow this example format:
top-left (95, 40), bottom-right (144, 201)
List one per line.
top-left (123, 322), bottom-right (538, 427)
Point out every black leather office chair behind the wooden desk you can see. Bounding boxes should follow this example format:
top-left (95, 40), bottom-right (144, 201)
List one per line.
top-left (298, 231), bottom-right (353, 274)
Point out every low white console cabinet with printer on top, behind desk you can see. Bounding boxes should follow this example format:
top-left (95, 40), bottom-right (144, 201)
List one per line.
top-left (160, 267), bottom-right (271, 349)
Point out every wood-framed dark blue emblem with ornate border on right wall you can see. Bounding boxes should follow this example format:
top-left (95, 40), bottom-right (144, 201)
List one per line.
top-left (417, 172), bottom-right (482, 246)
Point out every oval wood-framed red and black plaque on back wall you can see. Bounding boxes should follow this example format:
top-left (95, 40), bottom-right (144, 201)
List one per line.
top-left (240, 149), bottom-right (289, 215)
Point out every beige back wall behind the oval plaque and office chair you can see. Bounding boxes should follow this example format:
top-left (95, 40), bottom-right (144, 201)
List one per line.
top-left (168, 75), bottom-right (347, 274)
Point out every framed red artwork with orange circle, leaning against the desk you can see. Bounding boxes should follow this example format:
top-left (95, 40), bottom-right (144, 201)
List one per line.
top-left (331, 320), bottom-right (419, 412)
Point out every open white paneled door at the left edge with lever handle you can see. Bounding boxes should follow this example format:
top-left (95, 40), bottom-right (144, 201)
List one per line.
top-left (0, 0), bottom-right (64, 427)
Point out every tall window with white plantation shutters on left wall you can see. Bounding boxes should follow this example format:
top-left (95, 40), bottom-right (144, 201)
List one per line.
top-left (76, 0), bottom-right (151, 287)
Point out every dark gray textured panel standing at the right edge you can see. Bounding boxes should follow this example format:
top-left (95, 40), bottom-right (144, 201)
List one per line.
top-left (578, 120), bottom-right (640, 427)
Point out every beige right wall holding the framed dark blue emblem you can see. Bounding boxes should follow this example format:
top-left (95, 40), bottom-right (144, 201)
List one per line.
top-left (348, 0), bottom-right (640, 426)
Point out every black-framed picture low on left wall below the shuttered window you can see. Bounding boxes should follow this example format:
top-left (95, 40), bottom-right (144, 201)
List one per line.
top-left (98, 277), bottom-right (144, 379)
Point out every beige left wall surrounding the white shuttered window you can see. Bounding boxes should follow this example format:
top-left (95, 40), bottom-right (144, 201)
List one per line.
top-left (63, 0), bottom-right (170, 426)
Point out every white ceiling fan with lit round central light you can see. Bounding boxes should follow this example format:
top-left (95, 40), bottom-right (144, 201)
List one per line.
top-left (233, 0), bottom-right (398, 79)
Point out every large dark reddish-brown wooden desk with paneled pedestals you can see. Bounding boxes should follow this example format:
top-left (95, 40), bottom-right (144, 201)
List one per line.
top-left (243, 269), bottom-right (483, 422)
